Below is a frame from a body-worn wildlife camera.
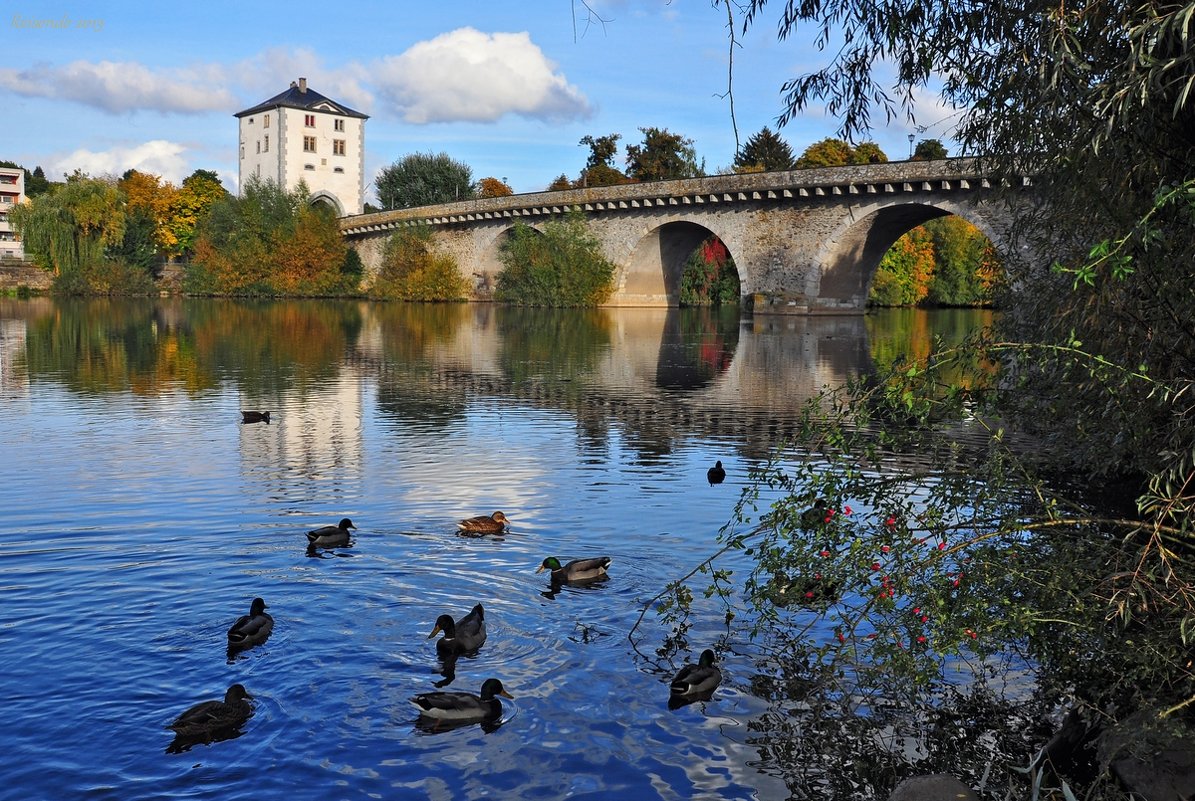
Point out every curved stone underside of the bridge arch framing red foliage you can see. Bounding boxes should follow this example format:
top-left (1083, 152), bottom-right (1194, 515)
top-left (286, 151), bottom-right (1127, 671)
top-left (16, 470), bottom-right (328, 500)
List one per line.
top-left (612, 220), bottom-right (734, 306)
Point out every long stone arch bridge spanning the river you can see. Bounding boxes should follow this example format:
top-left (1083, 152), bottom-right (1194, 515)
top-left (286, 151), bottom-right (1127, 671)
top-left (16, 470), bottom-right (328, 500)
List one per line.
top-left (341, 159), bottom-right (1030, 314)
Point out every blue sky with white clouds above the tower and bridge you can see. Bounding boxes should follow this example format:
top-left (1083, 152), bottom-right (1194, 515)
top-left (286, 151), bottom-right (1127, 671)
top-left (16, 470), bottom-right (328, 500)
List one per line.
top-left (0, 0), bottom-right (949, 197)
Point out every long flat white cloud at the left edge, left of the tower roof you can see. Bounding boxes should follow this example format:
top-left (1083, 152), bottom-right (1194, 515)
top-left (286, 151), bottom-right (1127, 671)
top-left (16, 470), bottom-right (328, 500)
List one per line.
top-left (0, 61), bottom-right (237, 114)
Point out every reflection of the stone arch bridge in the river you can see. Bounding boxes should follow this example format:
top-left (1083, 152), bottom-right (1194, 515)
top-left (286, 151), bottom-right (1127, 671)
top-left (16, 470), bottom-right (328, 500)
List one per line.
top-left (350, 305), bottom-right (870, 458)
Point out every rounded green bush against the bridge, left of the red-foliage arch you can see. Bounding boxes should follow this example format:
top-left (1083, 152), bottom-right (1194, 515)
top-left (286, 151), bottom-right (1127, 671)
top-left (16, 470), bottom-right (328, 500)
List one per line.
top-left (495, 213), bottom-right (614, 306)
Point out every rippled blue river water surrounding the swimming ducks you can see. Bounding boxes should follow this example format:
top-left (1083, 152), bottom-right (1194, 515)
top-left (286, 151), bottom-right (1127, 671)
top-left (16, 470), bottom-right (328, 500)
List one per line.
top-left (0, 299), bottom-right (989, 801)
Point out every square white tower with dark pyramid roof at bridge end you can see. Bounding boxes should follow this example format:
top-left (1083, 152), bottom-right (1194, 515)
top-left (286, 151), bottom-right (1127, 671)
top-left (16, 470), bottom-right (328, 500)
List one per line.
top-left (234, 78), bottom-right (369, 216)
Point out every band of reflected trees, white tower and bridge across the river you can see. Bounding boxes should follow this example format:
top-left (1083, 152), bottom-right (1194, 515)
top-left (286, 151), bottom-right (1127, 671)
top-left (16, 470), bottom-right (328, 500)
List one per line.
top-left (0, 299), bottom-right (976, 471)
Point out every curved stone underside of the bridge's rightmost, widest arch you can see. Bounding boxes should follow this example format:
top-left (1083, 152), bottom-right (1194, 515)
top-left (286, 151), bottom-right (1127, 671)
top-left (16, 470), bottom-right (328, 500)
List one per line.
top-left (817, 201), bottom-right (1006, 308)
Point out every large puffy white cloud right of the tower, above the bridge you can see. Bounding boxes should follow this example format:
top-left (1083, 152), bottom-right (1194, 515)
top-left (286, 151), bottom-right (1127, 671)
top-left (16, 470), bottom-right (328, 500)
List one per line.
top-left (370, 27), bottom-right (590, 124)
